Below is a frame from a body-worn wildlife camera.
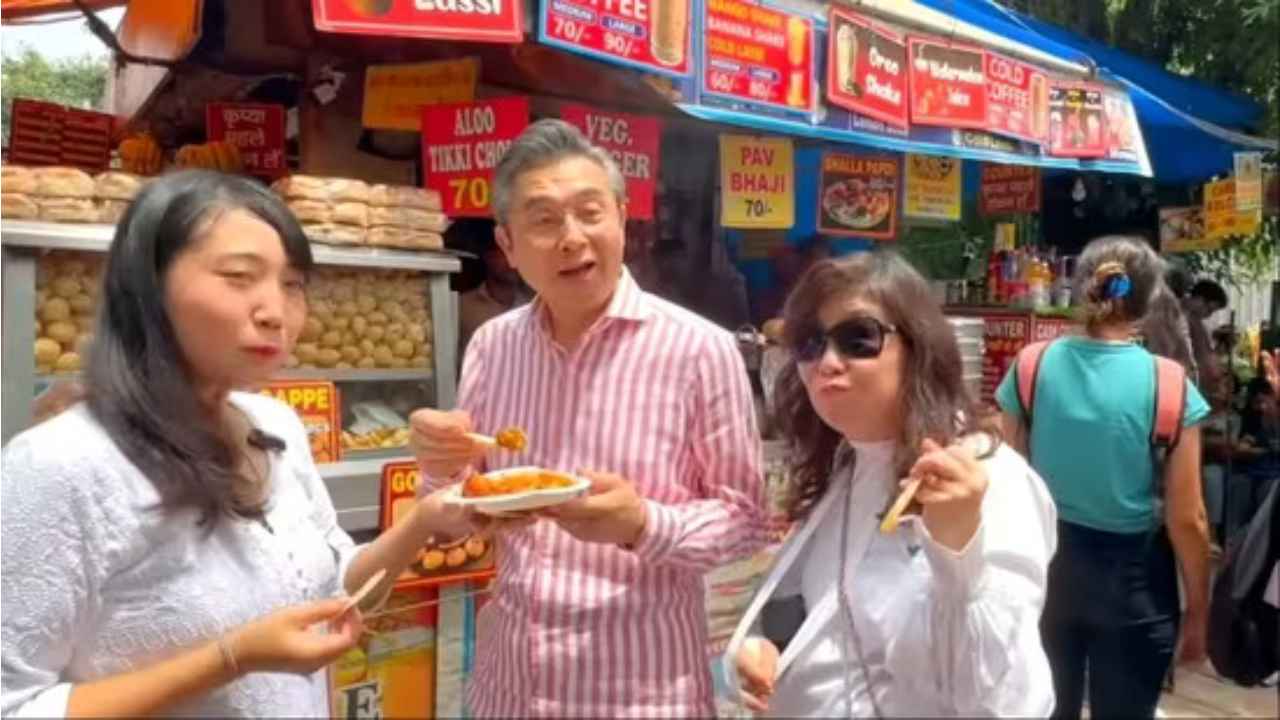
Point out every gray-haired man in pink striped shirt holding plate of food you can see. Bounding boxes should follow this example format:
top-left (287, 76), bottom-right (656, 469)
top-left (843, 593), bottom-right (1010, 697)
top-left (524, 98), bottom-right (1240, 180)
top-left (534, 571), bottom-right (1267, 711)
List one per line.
top-left (412, 120), bottom-right (765, 717)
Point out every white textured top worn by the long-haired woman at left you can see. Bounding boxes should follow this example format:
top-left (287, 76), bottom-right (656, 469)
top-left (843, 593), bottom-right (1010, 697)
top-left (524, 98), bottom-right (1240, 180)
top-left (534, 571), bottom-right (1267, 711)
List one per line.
top-left (0, 393), bottom-right (356, 717)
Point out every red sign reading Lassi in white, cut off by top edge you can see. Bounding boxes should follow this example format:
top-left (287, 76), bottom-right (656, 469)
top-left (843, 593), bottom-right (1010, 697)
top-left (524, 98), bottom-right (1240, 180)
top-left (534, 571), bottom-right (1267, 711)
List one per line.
top-left (311, 0), bottom-right (525, 42)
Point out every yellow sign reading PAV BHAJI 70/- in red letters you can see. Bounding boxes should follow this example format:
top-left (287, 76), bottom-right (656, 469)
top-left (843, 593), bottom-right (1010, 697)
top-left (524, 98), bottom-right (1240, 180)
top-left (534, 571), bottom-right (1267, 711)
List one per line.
top-left (721, 135), bottom-right (796, 229)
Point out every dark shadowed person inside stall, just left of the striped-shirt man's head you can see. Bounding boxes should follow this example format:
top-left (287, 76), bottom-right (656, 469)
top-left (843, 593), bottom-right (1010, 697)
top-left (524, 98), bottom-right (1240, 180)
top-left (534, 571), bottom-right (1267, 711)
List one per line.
top-left (445, 219), bottom-right (532, 359)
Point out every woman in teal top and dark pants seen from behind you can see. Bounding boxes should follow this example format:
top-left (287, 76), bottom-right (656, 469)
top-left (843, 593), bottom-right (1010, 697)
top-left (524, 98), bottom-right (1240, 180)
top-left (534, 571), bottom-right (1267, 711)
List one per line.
top-left (996, 236), bottom-right (1210, 719)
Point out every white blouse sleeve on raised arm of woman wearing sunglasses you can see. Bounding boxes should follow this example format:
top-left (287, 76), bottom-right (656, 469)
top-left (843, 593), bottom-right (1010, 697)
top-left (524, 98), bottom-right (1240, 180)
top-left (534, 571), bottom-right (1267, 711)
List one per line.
top-left (887, 447), bottom-right (1057, 717)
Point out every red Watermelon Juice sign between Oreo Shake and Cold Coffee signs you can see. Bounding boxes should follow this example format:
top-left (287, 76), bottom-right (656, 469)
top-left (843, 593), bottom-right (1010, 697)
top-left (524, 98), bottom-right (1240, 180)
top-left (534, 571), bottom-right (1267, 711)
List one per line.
top-left (910, 37), bottom-right (987, 129)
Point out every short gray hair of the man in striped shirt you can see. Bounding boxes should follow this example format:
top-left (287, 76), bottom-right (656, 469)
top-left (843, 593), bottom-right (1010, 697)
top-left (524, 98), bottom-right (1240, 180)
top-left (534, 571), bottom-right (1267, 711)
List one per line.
top-left (493, 119), bottom-right (627, 224)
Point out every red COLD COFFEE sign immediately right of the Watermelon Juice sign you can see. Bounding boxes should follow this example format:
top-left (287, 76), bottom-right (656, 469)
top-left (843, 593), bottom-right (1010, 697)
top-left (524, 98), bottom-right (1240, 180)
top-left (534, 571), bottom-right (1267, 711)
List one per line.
top-left (986, 53), bottom-right (1048, 142)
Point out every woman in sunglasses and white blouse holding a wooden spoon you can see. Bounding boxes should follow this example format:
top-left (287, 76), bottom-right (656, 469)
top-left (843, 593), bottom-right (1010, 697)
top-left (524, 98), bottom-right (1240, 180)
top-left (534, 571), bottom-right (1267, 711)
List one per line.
top-left (728, 252), bottom-right (1056, 717)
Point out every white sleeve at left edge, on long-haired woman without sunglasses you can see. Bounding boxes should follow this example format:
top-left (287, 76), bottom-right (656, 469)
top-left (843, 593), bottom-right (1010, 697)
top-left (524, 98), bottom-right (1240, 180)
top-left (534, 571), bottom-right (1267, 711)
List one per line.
top-left (0, 425), bottom-right (115, 717)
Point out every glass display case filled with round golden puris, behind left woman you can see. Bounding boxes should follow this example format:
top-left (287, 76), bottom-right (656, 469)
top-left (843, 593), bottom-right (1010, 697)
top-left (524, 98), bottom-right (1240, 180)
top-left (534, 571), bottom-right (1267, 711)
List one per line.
top-left (0, 220), bottom-right (460, 532)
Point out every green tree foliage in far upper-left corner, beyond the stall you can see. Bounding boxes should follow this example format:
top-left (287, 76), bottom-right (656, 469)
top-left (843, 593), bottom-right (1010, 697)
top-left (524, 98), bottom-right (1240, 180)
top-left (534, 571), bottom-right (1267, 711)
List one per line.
top-left (0, 47), bottom-right (110, 143)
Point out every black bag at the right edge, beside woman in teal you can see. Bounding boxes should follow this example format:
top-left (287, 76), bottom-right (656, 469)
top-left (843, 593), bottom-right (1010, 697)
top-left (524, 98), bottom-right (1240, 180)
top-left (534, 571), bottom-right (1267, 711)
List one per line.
top-left (1208, 482), bottom-right (1280, 687)
